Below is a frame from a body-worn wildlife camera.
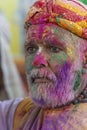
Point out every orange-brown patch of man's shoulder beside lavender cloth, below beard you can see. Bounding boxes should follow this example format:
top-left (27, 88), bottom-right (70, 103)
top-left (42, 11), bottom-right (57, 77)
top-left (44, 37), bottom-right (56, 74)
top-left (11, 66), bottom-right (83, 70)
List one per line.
top-left (13, 97), bottom-right (35, 130)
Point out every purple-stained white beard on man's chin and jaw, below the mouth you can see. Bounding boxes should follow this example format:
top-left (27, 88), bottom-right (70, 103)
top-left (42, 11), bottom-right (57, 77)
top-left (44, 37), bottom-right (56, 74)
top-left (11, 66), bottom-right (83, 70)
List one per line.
top-left (30, 79), bottom-right (74, 108)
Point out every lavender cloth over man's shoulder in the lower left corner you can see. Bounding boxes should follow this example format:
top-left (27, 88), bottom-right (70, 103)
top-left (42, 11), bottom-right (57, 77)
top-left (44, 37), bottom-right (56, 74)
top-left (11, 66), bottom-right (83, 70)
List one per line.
top-left (0, 99), bottom-right (23, 130)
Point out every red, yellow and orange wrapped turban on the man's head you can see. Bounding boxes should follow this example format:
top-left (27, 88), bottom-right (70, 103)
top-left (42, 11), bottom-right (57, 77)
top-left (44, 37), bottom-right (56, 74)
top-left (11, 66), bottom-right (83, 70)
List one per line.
top-left (25, 0), bottom-right (87, 39)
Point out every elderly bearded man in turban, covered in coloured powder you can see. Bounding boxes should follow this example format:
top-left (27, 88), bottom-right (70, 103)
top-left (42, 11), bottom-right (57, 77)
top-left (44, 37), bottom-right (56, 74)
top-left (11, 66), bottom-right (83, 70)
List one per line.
top-left (0, 0), bottom-right (87, 130)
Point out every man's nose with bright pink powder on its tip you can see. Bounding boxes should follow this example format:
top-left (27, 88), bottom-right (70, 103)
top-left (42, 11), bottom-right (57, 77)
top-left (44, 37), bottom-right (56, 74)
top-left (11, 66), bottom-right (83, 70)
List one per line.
top-left (33, 53), bottom-right (48, 67)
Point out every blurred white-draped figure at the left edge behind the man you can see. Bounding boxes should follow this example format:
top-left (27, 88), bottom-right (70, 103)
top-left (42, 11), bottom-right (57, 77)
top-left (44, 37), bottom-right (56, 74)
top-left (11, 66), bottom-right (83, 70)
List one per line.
top-left (0, 11), bottom-right (26, 100)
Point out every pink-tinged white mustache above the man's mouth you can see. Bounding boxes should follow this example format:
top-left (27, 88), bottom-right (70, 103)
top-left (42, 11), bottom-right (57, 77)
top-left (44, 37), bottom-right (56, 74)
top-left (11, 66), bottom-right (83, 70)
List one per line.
top-left (30, 68), bottom-right (57, 82)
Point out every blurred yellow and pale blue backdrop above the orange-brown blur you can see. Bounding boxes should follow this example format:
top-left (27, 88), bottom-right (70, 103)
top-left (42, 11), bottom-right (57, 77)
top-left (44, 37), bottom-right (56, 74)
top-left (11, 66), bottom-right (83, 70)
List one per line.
top-left (0, 0), bottom-right (35, 57)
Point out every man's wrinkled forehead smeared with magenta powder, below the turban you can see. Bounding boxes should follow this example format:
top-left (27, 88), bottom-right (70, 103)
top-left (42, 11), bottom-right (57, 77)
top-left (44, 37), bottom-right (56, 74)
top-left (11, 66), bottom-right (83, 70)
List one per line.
top-left (26, 24), bottom-right (77, 44)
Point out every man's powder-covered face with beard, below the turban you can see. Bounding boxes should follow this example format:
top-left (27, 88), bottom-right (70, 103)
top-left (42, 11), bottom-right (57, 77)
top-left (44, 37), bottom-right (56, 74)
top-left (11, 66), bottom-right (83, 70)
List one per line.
top-left (25, 24), bottom-right (82, 107)
